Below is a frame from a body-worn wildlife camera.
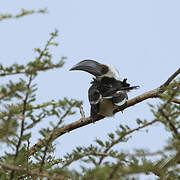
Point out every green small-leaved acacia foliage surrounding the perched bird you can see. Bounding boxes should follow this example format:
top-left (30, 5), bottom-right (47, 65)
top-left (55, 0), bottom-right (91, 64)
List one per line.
top-left (0, 5), bottom-right (180, 180)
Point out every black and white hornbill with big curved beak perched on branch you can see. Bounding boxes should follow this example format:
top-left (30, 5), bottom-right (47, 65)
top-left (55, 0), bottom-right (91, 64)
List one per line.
top-left (70, 59), bottom-right (139, 121)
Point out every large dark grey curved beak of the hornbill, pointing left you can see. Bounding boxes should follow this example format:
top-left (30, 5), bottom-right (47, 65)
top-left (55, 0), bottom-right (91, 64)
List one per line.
top-left (70, 59), bottom-right (108, 76)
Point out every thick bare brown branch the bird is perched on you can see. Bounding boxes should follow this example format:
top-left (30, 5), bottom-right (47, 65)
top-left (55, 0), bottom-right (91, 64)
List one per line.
top-left (30, 68), bottom-right (180, 155)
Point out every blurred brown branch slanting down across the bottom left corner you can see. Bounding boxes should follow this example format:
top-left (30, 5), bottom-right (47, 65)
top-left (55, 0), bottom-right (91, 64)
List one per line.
top-left (0, 162), bottom-right (64, 180)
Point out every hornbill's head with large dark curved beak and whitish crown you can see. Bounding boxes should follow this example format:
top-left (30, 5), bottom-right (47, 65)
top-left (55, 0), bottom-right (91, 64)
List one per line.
top-left (70, 59), bottom-right (119, 79)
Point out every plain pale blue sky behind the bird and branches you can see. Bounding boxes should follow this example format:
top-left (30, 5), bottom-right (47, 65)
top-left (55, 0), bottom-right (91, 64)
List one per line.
top-left (0, 0), bottom-right (180, 179)
